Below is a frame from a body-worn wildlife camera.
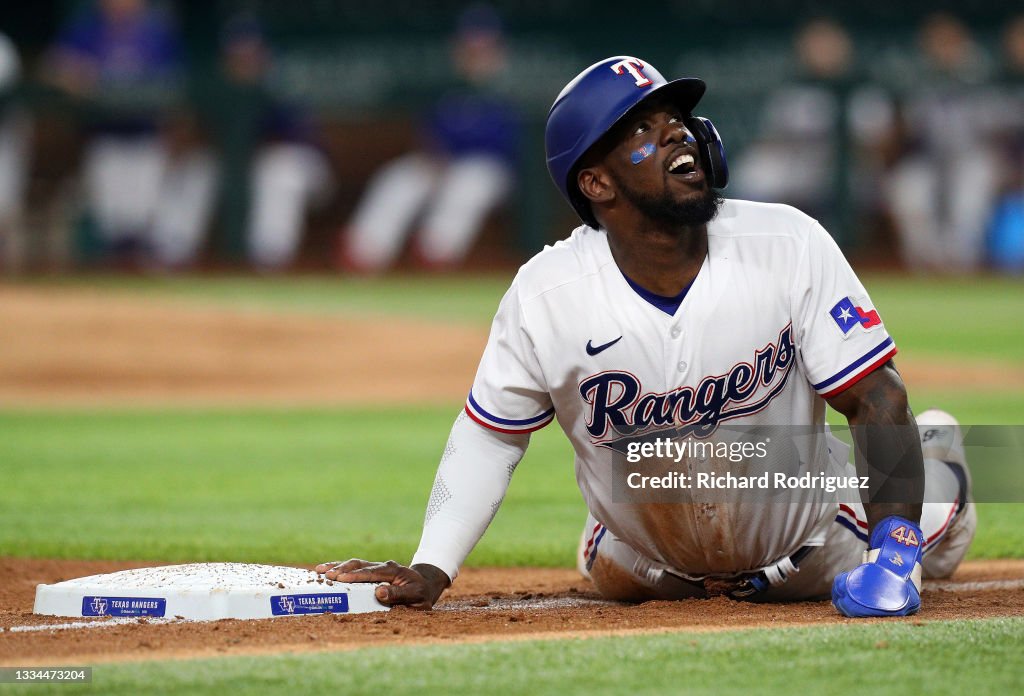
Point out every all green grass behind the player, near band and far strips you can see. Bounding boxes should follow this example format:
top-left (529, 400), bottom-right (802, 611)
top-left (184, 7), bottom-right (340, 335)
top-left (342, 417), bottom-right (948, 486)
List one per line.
top-left (0, 273), bottom-right (1024, 566)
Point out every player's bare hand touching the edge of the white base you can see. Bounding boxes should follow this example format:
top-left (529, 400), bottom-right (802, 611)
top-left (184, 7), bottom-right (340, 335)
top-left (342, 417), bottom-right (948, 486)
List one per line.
top-left (315, 558), bottom-right (452, 609)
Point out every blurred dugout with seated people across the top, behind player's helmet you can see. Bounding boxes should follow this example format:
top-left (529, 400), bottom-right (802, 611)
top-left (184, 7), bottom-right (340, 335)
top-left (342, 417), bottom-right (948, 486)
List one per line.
top-left (0, 0), bottom-right (1024, 272)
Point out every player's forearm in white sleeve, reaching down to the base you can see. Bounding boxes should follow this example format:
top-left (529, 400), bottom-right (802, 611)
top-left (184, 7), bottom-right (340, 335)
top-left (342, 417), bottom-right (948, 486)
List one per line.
top-left (413, 407), bottom-right (529, 590)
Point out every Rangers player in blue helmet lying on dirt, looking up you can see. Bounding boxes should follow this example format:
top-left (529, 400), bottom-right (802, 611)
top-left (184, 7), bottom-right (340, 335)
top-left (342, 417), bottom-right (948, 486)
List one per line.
top-left (316, 56), bottom-right (976, 616)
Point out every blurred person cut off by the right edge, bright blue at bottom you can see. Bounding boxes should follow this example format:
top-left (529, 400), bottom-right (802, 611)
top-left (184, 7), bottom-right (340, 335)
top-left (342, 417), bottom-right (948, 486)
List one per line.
top-left (987, 14), bottom-right (1024, 273)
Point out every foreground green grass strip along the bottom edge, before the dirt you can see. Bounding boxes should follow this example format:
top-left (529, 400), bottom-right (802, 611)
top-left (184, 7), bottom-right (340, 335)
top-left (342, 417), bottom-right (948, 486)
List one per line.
top-left (6, 619), bottom-right (1024, 696)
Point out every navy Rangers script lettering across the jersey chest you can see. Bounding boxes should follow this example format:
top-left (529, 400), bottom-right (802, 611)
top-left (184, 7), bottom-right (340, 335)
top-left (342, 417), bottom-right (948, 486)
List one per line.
top-left (580, 323), bottom-right (797, 449)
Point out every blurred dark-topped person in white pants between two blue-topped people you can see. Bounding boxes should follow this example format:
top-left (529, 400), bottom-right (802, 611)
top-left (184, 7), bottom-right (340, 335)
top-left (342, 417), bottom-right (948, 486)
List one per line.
top-left (201, 14), bottom-right (333, 270)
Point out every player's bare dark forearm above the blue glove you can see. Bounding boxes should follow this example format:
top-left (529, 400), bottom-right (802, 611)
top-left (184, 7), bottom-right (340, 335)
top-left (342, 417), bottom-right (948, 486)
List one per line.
top-left (829, 363), bottom-right (925, 529)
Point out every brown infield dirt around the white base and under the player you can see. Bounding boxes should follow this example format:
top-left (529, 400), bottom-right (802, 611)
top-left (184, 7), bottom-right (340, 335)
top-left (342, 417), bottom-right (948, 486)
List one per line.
top-left (0, 558), bottom-right (1024, 666)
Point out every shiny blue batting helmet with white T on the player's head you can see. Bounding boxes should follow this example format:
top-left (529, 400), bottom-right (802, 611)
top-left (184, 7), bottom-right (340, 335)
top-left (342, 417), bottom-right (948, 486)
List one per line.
top-left (544, 55), bottom-right (728, 227)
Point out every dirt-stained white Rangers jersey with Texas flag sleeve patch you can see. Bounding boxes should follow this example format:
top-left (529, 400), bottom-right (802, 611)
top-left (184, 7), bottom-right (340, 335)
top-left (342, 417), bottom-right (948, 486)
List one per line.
top-left (466, 201), bottom-right (896, 575)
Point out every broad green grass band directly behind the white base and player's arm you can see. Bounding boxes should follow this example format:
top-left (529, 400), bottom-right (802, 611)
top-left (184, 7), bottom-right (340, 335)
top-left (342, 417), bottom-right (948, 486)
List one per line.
top-left (0, 406), bottom-right (1024, 566)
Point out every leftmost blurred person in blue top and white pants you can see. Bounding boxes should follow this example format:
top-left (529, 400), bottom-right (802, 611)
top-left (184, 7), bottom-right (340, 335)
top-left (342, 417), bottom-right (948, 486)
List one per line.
top-left (48, 0), bottom-right (214, 266)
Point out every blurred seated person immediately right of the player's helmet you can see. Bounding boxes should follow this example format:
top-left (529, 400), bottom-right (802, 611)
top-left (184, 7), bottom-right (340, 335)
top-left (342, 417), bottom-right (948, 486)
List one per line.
top-left (732, 18), bottom-right (888, 243)
